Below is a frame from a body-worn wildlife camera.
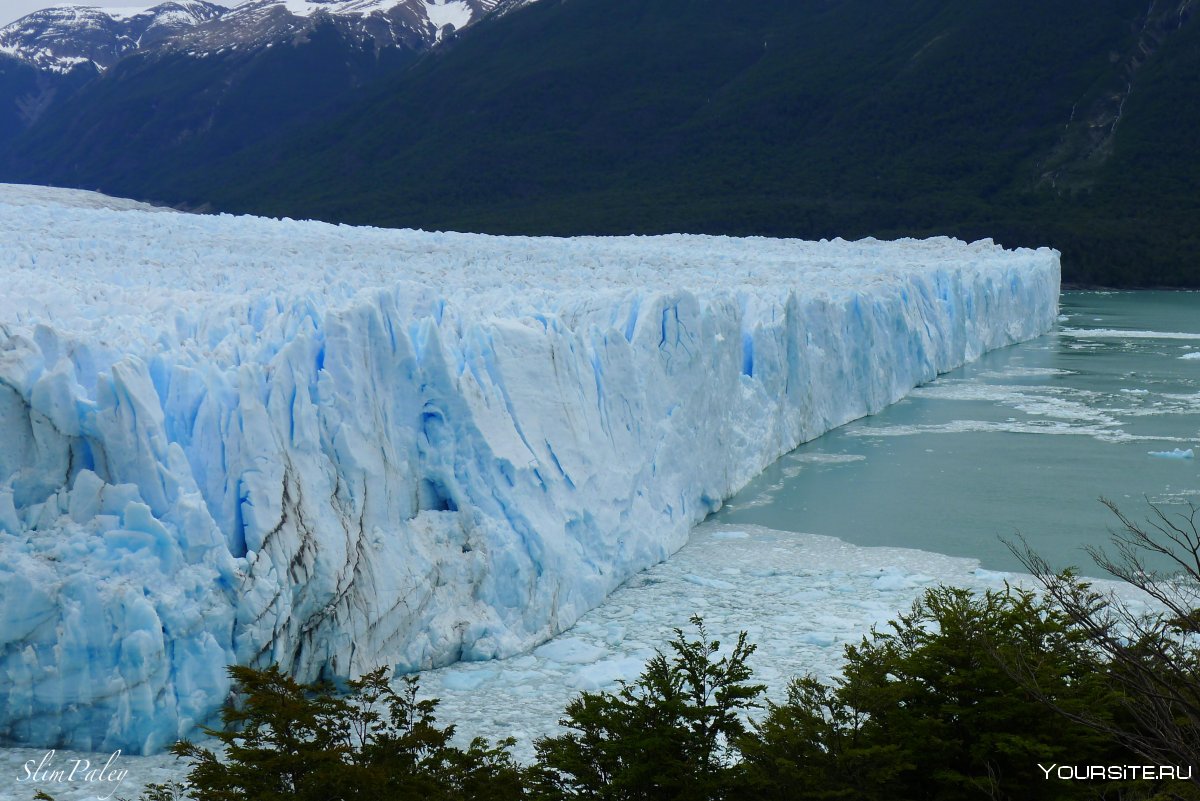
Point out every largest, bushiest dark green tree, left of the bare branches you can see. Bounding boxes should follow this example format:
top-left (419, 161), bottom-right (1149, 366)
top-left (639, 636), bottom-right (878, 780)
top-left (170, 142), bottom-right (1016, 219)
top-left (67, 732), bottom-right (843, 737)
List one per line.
top-left (743, 588), bottom-right (1121, 801)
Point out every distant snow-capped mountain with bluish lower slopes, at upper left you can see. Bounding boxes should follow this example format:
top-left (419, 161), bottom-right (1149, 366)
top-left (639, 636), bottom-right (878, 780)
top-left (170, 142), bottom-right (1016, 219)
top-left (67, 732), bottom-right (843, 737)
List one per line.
top-left (0, 0), bottom-right (530, 182)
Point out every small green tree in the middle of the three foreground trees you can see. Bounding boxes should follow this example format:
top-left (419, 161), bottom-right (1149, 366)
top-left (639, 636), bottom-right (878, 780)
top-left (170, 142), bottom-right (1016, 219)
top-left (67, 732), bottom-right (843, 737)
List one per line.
top-left (536, 618), bottom-right (766, 801)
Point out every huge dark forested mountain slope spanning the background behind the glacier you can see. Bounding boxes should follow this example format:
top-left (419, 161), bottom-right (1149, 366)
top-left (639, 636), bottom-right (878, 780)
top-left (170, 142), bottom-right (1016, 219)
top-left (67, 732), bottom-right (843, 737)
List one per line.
top-left (4, 0), bottom-right (1200, 285)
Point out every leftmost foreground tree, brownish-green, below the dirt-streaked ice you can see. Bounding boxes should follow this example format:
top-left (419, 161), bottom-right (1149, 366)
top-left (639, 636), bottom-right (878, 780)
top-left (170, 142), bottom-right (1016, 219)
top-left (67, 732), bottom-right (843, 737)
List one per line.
top-left (173, 666), bottom-right (524, 801)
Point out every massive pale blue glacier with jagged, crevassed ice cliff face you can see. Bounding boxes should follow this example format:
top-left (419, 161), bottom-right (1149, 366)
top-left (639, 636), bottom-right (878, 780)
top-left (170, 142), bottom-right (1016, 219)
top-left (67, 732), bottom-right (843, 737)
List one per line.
top-left (0, 186), bottom-right (1058, 752)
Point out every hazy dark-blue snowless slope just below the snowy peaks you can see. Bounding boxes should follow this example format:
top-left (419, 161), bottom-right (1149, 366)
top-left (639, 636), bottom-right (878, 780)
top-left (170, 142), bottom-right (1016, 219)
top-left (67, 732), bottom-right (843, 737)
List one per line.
top-left (0, 20), bottom-right (416, 187)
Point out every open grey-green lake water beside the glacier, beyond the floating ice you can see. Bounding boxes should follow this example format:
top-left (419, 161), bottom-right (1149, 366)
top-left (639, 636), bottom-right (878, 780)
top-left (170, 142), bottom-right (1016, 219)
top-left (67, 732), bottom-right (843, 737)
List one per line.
top-left (713, 293), bottom-right (1200, 574)
